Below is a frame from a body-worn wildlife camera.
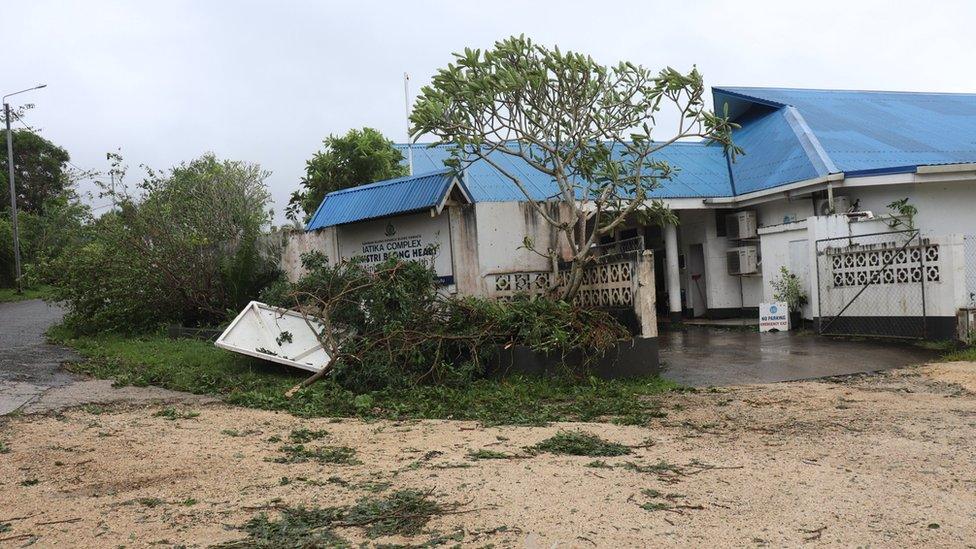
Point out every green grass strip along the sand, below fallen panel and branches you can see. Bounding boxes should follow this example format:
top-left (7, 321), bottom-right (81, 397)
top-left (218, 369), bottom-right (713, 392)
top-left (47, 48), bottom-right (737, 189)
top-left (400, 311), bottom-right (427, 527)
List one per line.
top-left (48, 327), bottom-right (678, 425)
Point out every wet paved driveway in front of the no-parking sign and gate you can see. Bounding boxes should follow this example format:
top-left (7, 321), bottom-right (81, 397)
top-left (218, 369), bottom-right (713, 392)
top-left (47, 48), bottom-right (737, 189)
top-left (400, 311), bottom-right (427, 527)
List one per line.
top-left (659, 326), bottom-right (938, 387)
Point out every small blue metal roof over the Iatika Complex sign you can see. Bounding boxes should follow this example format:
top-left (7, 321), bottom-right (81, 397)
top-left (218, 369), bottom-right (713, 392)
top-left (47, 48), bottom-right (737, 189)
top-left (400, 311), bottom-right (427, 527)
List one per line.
top-left (305, 169), bottom-right (463, 231)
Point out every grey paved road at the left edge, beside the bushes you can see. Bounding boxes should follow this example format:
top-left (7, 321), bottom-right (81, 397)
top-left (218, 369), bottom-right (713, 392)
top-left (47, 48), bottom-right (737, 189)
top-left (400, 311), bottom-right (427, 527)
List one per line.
top-left (0, 299), bottom-right (214, 416)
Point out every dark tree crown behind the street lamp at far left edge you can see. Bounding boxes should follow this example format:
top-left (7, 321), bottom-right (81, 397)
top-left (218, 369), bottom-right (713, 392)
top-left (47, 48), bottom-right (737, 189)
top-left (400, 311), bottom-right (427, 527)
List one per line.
top-left (0, 130), bottom-right (71, 214)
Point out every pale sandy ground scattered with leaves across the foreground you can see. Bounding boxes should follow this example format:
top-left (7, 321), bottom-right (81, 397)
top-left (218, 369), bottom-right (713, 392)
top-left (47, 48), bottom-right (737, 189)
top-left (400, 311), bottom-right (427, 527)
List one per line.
top-left (0, 363), bottom-right (976, 547)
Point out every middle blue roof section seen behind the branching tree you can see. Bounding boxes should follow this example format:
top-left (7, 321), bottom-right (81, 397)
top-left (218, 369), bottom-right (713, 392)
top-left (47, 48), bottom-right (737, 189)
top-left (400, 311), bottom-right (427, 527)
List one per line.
top-left (397, 142), bottom-right (732, 202)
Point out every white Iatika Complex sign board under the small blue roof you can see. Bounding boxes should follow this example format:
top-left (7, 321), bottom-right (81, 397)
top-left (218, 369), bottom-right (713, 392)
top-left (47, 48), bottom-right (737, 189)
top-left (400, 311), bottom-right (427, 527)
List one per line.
top-left (336, 212), bottom-right (454, 284)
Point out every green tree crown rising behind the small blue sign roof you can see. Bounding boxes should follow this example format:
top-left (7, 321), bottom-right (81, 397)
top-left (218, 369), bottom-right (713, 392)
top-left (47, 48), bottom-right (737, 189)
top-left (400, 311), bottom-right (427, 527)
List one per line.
top-left (285, 128), bottom-right (408, 219)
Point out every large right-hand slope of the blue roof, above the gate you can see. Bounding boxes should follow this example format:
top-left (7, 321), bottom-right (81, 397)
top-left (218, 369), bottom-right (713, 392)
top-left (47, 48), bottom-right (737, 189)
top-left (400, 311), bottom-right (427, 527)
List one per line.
top-left (713, 87), bottom-right (976, 176)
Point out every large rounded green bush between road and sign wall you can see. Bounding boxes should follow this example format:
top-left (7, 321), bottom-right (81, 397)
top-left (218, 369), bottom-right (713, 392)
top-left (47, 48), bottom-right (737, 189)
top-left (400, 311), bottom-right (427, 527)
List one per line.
top-left (47, 154), bottom-right (278, 333)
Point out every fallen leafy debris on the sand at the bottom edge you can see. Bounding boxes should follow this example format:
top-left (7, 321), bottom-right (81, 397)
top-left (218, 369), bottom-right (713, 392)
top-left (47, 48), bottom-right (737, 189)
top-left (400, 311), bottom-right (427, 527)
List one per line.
top-left (216, 490), bottom-right (457, 549)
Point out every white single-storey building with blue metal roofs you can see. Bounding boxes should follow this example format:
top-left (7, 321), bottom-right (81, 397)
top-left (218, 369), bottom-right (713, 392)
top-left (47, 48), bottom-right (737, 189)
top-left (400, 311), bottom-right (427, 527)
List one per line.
top-left (286, 87), bottom-right (976, 339)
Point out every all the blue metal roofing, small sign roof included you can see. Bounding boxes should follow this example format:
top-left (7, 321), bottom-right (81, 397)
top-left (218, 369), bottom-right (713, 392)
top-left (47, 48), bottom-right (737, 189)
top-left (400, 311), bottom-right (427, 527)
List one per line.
top-left (308, 87), bottom-right (976, 230)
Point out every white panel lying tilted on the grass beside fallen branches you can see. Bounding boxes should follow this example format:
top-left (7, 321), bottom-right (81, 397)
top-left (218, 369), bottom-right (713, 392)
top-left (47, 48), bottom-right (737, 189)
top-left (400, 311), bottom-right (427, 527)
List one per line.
top-left (214, 301), bottom-right (332, 372)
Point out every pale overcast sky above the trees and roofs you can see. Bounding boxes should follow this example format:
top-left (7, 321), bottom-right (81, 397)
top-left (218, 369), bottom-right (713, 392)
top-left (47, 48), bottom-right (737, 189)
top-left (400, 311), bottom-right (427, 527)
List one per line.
top-left (11, 0), bottom-right (976, 220)
